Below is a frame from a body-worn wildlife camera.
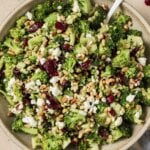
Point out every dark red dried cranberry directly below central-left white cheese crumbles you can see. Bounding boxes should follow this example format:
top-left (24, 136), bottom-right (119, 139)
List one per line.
top-left (47, 94), bottom-right (61, 109)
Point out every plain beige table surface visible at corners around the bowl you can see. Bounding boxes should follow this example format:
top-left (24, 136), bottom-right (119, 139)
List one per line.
top-left (0, 0), bottom-right (150, 150)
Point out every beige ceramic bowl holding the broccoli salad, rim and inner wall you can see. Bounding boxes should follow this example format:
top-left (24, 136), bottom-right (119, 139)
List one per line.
top-left (0, 0), bottom-right (150, 150)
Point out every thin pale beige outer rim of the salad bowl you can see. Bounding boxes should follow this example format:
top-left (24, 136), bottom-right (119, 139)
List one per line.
top-left (0, 0), bottom-right (150, 150)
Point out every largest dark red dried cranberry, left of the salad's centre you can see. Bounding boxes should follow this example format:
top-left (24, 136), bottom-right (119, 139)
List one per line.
top-left (42, 59), bottom-right (58, 77)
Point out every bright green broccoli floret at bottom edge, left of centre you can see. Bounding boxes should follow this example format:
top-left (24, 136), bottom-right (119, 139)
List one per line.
top-left (42, 134), bottom-right (70, 150)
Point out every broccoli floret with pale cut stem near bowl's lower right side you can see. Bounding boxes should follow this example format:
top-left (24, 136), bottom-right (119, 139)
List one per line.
top-left (125, 105), bottom-right (143, 124)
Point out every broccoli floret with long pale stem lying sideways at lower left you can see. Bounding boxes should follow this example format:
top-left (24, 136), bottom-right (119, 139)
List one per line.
top-left (12, 117), bottom-right (38, 135)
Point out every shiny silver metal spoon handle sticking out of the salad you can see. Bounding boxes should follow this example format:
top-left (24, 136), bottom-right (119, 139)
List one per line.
top-left (106, 0), bottom-right (123, 23)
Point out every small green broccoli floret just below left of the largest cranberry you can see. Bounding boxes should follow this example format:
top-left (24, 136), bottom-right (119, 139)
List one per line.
top-left (31, 70), bottom-right (48, 84)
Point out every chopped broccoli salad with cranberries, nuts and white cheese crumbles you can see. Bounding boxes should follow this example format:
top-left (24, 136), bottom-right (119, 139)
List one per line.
top-left (0, 0), bottom-right (150, 150)
